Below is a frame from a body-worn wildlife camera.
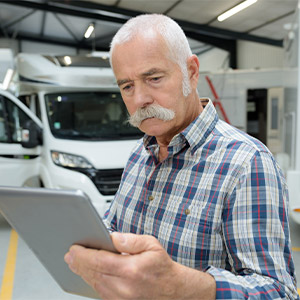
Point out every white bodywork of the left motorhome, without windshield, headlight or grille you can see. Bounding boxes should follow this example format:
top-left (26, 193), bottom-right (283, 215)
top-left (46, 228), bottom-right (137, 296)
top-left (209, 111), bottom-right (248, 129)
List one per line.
top-left (0, 53), bottom-right (141, 215)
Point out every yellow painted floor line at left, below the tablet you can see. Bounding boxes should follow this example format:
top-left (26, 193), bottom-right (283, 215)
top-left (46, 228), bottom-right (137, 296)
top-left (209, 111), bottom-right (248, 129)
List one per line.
top-left (0, 229), bottom-right (18, 300)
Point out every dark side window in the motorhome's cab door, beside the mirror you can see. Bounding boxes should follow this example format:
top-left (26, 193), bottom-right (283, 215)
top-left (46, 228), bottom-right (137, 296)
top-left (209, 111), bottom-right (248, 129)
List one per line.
top-left (6, 100), bottom-right (30, 143)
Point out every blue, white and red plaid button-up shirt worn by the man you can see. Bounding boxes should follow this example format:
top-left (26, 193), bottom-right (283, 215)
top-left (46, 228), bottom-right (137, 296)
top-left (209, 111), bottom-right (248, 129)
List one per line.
top-left (105, 101), bottom-right (298, 300)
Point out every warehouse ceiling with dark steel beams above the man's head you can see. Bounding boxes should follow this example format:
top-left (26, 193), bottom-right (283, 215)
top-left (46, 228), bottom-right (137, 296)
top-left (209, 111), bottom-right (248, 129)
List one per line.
top-left (0, 0), bottom-right (298, 63)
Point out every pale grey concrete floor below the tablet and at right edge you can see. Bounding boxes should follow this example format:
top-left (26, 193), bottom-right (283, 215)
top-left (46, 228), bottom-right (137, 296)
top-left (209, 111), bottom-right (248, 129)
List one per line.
top-left (0, 215), bottom-right (300, 300)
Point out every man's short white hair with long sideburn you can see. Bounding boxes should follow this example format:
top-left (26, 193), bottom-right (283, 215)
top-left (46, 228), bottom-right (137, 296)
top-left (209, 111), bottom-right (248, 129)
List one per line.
top-left (110, 14), bottom-right (192, 97)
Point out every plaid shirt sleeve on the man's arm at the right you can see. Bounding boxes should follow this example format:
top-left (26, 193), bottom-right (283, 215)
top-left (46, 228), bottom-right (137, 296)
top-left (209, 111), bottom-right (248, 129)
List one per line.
top-left (206, 152), bottom-right (299, 300)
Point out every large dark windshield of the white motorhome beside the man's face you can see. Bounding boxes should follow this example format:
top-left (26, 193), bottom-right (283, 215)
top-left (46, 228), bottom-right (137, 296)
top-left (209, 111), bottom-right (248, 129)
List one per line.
top-left (45, 92), bottom-right (143, 140)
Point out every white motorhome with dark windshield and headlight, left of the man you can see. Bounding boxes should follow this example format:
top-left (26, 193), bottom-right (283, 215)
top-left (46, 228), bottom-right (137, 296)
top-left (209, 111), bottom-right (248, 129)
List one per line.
top-left (0, 54), bottom-right (142, 215)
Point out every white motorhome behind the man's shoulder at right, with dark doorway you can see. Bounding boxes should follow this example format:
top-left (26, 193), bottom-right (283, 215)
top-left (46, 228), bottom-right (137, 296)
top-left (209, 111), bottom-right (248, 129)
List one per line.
top-left (198, 68), bottom-right (300, 224)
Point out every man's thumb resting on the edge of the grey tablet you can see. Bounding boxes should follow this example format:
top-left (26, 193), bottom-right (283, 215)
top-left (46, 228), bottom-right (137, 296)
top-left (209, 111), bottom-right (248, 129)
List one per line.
top-left (111, 232), bottom-right (161, 254)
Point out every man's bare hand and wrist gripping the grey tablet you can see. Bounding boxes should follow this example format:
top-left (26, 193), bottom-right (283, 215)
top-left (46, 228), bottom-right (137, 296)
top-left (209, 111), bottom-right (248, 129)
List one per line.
top-left (65, 233), bottom-right (216, 300)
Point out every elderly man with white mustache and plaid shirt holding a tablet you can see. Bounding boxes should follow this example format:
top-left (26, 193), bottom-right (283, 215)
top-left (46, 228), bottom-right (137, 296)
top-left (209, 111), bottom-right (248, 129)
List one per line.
top-left (65, 14), bottom-right (298, 300)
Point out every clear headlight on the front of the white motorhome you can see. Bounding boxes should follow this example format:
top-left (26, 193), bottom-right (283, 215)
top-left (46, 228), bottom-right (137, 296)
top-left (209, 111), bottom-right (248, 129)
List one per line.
top-left (51, 151), bottom-right (93, 169)
